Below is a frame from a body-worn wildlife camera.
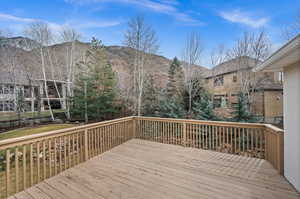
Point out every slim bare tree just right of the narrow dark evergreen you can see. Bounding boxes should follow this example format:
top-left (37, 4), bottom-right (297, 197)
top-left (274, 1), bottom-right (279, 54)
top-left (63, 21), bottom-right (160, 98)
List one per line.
top-left (182, 32), bottom-right (203, 114)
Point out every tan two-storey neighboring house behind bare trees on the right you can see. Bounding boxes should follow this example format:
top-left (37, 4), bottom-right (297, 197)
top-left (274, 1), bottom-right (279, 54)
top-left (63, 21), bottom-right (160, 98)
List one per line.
top-left (205, 57), bottom-right (283, 123)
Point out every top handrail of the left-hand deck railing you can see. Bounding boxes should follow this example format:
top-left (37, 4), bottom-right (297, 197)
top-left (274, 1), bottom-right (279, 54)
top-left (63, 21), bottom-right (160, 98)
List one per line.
top-left (0, 116), bottom-right (134, 150)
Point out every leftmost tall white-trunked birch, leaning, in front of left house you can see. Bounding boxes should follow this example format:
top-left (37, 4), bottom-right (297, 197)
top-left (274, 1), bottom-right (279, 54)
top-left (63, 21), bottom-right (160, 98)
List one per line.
top-left (24, 22), bottom-right (54, 120)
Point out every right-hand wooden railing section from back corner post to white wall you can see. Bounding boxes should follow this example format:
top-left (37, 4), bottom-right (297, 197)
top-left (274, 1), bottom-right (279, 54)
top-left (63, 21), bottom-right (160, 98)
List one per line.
top-left (136, 117), bottom-right (283, 174)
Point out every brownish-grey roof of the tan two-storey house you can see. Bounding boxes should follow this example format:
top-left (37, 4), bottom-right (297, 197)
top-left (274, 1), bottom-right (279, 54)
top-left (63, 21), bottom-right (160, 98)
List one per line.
top-left (205, 56), bottom-right (258, 78)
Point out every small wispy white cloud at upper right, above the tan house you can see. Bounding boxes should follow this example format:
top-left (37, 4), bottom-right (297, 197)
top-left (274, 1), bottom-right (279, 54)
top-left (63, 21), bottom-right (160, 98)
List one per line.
top-left (219, 9), bottom-right (269, 28)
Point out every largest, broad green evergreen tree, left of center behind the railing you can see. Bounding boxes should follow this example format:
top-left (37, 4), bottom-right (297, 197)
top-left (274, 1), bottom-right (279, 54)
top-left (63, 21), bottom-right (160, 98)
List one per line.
top-left (71, 38), bottom-right (116, 120)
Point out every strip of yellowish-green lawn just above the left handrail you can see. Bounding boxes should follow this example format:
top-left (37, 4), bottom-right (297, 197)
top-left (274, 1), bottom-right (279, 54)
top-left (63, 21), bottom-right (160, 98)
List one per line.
top-left (0, 124), bottom-right (75, 140)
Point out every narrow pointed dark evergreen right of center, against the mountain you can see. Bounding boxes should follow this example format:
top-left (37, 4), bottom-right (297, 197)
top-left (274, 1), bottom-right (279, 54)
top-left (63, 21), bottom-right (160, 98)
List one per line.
top-left (166, 57), bottom-right (183, 98)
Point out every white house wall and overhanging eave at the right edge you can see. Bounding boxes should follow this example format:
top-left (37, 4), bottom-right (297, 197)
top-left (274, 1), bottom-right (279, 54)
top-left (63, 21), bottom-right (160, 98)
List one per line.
top-left (254, 35), bottom-right (300, 191)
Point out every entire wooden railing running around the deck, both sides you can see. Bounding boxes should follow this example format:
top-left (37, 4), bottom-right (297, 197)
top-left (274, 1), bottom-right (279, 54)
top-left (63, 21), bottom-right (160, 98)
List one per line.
top-left (0, 117), bottom-right (283, 198)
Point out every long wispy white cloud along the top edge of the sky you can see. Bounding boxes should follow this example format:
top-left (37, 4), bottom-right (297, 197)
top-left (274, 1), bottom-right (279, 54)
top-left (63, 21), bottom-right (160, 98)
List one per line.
top-left (65, 0), bottom-right (204, 25)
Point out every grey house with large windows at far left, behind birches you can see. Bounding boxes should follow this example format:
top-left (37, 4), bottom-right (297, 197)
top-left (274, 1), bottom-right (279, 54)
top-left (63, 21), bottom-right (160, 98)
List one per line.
top-left (0, 46), bottom-right (66, 114)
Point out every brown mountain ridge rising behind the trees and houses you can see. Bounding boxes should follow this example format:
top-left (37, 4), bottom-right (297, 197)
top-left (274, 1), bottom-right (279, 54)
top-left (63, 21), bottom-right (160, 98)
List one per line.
top-left (0, 37), bottom-right (209, 89)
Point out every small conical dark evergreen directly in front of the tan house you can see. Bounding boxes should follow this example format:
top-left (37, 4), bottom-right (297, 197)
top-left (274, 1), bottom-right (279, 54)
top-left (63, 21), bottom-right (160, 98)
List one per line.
top-left (231, 92), bottom-right (257, 122)
